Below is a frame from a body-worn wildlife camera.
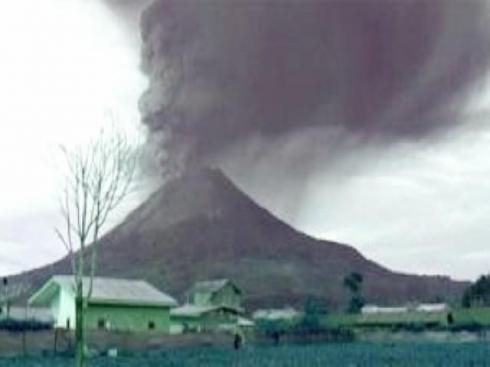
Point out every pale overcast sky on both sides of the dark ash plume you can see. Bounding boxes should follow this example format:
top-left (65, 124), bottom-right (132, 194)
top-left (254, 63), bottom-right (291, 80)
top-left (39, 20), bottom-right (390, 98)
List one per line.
top-left (0, 0), bottom-right (490, 278)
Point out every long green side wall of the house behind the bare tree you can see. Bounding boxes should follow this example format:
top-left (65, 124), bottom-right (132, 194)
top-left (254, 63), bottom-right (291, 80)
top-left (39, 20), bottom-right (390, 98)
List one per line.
top-left (85, 304), bottom-right (170, 332)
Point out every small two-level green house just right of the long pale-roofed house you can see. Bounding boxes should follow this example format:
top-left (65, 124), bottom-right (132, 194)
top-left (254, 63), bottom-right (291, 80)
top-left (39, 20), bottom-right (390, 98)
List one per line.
top-left (171, 279), bottom-right (251, 333)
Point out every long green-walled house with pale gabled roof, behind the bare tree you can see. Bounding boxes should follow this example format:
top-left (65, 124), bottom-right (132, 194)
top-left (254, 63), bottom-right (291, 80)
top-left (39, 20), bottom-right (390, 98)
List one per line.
top-left (28, 275), bottom-right (177, 332)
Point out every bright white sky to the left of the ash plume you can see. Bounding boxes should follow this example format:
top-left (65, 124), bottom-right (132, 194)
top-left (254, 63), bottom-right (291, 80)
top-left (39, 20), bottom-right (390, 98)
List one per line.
top-left (0, 0), bottom-right (146, 274)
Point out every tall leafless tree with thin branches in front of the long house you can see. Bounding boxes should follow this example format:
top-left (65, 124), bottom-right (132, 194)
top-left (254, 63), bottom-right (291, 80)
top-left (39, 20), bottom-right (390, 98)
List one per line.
top-left (56, 131), bottom-right (138, 367)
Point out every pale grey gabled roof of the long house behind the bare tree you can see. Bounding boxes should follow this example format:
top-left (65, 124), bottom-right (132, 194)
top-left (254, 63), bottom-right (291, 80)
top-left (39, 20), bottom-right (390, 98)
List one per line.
top-left (29, 275), bottom-right (177, 307)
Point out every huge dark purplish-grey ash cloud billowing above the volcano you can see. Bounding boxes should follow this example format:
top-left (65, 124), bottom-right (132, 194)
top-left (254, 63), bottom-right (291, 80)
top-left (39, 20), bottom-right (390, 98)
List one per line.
top-left (140, 0), bottom-right (490, 170)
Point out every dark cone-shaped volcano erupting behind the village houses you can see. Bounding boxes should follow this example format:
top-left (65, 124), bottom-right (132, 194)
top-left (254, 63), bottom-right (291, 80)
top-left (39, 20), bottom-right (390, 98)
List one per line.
top-left (15, 169), bottom-right (467, 309)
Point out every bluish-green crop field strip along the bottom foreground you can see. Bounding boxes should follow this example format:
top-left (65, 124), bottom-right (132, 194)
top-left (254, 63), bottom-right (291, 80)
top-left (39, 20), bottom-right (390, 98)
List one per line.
top-left (0, 343), bottom-right (490, 367)
